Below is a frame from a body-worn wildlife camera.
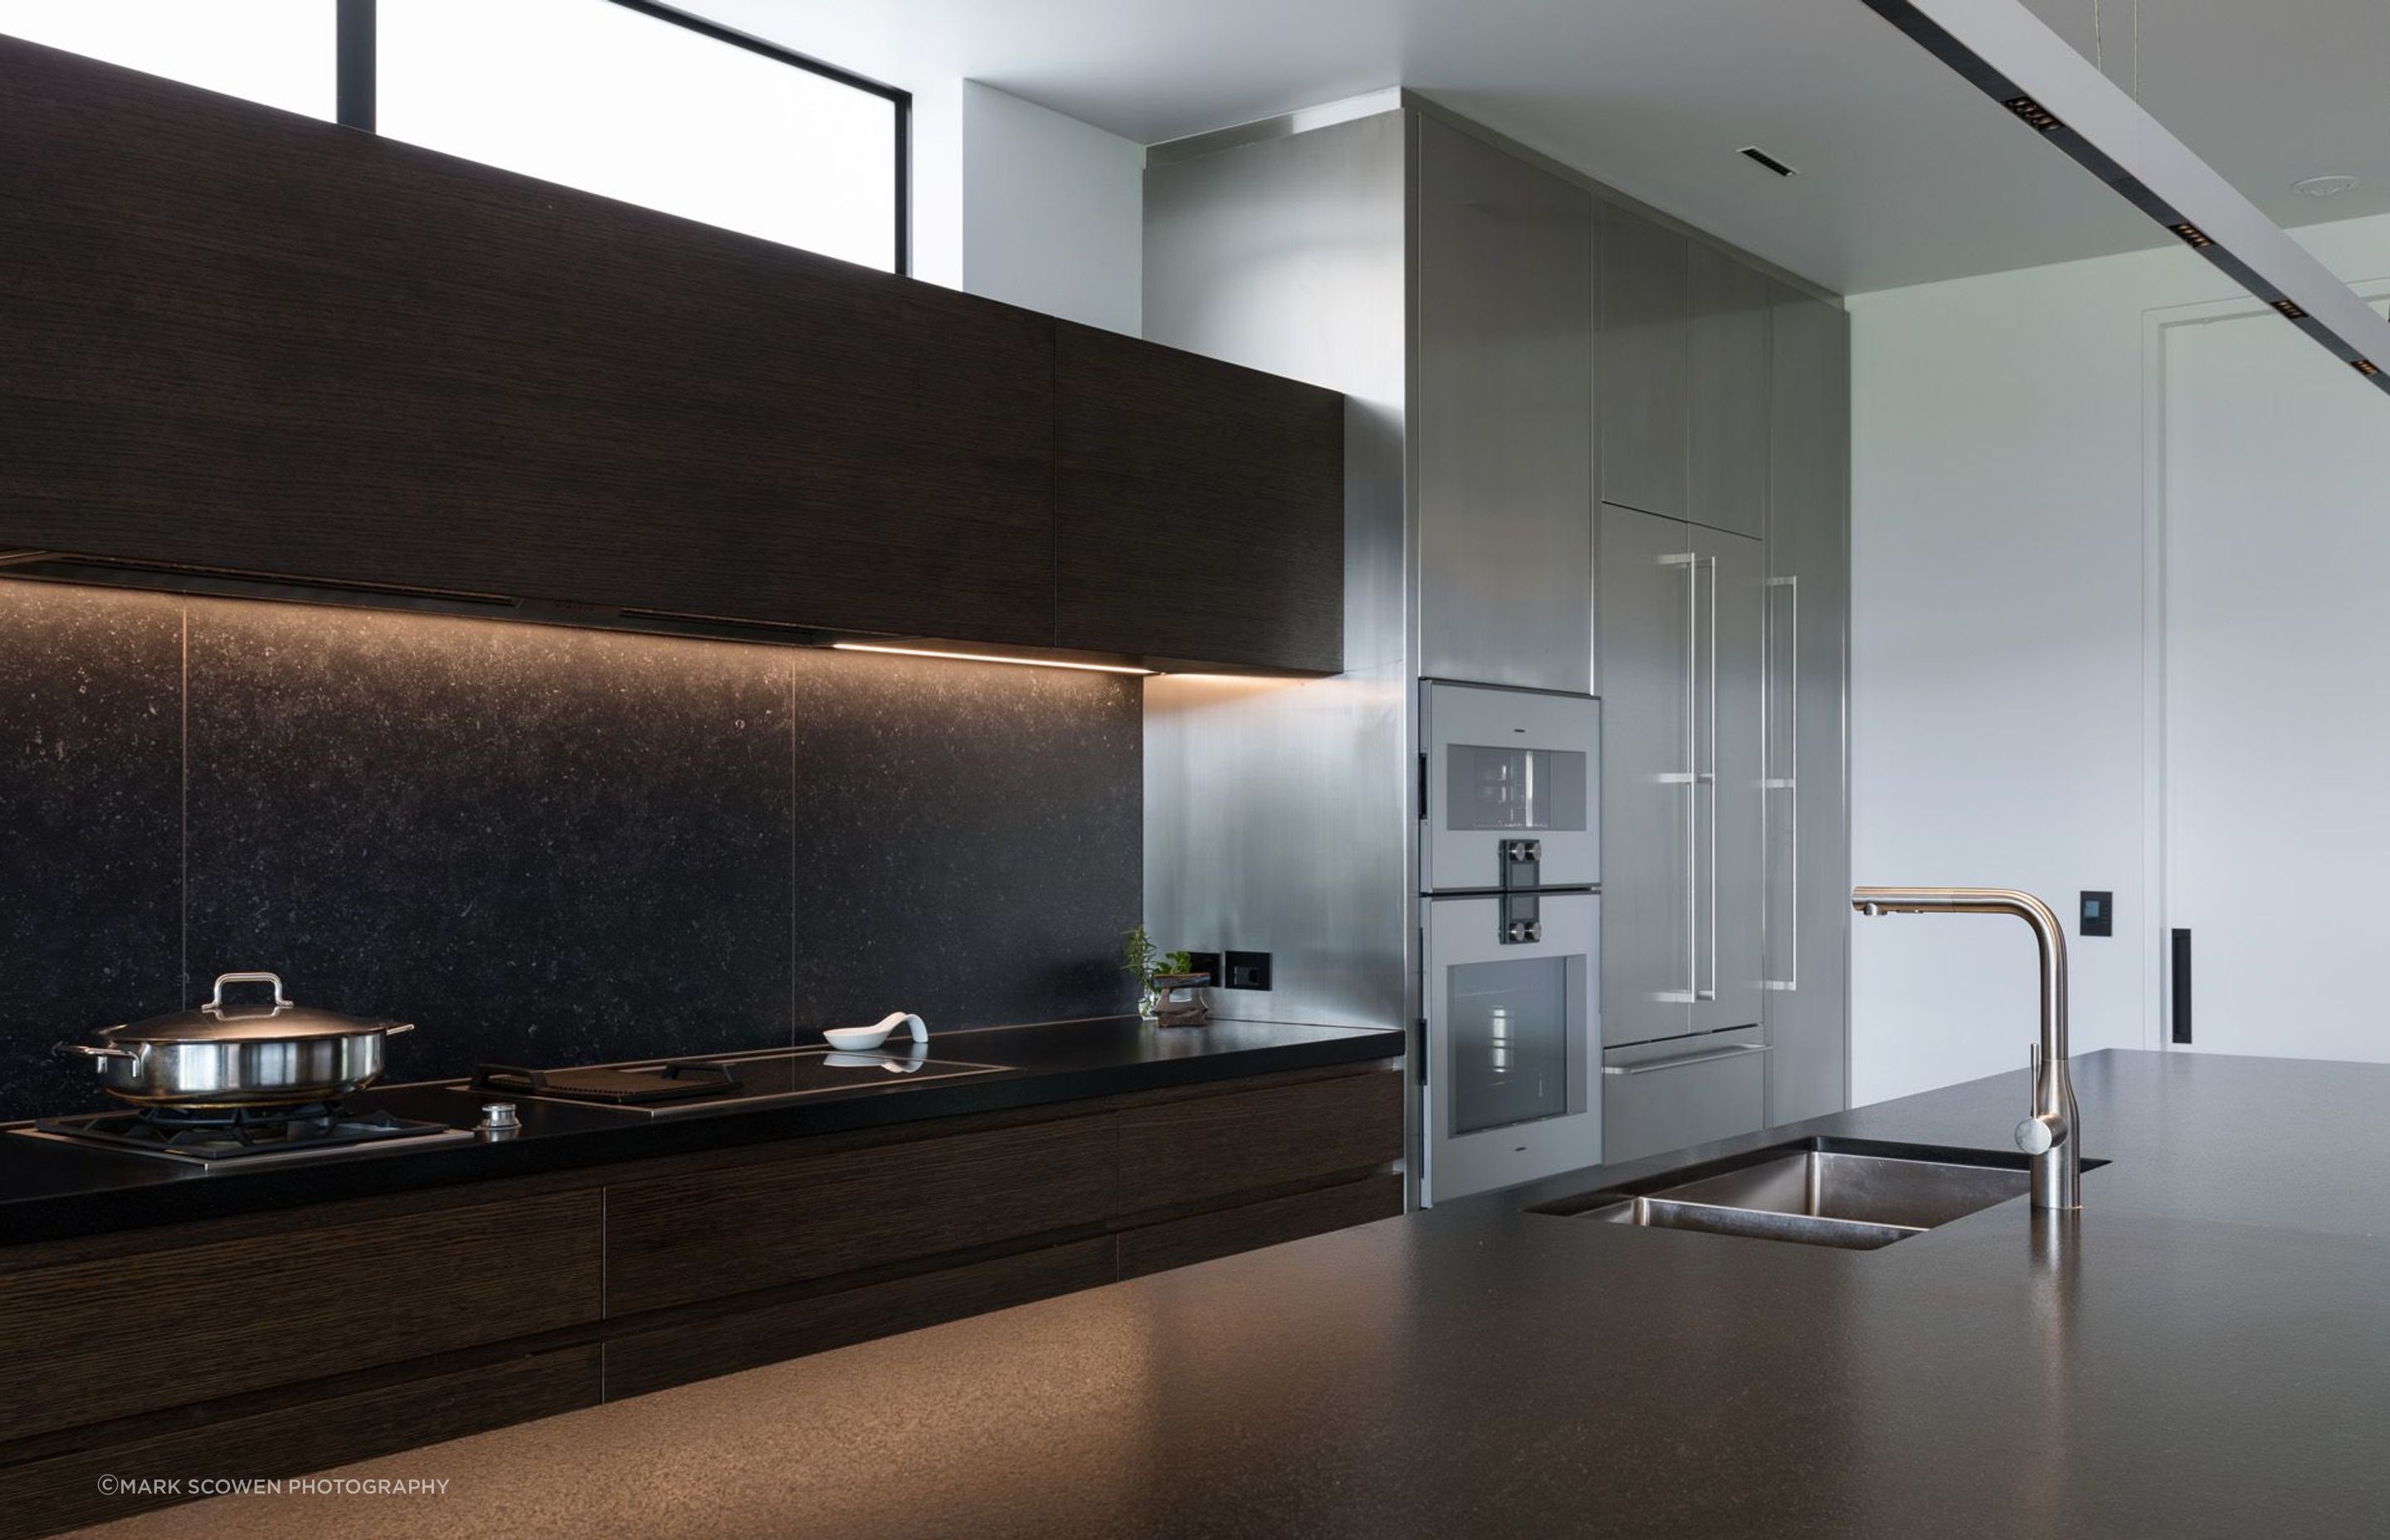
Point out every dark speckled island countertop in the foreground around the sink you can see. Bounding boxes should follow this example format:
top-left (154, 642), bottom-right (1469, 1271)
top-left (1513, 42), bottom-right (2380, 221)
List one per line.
top-left (56, 1052), bottom-right (2390, 1540)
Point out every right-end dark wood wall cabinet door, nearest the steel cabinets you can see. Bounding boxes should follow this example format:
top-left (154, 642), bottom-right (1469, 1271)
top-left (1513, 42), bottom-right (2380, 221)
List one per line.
top-left (1054, 320), bottom-right (1344, 675)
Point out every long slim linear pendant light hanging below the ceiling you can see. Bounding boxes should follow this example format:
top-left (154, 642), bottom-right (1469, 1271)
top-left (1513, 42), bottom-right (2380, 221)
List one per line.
top-left (1864, 0), bottom-right (2390, 392)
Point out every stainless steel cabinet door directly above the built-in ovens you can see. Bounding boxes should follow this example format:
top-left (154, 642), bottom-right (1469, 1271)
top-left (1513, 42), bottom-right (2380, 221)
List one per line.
top-left (1410, 117), bottom-right (1594, 694)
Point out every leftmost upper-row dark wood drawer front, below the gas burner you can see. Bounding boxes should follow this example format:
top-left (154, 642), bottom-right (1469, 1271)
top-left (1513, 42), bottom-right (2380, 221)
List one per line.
top-left (0, 1191), bottom-right (600, 1442)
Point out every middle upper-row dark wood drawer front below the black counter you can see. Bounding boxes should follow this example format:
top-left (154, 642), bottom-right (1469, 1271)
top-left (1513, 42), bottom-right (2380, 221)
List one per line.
top-left (607, 1117), bottom-right (1114, 1315)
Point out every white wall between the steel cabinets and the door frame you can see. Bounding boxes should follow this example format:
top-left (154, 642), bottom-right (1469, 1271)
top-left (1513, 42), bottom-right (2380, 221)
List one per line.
top-left (1850, 217), bottom-right (2390, 1103)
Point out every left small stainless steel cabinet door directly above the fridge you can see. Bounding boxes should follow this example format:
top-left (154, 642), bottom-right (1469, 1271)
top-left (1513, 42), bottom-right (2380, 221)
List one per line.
top-left (1602, 206), bottom-right (1692, 519)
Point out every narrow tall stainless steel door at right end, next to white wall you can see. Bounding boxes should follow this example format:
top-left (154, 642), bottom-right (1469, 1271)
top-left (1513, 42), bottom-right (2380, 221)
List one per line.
top-left (1763, 285), bottom-right (1850, 1124)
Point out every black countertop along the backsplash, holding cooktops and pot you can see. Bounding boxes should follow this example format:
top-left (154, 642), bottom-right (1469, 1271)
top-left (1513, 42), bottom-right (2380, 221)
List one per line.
top-left (0, 1016), bottom-right (1405, 1246)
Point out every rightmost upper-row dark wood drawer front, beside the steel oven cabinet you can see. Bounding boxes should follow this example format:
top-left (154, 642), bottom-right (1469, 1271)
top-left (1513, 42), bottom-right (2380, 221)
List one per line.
top-left (1119, 1071), bottom-right (1403, 1215)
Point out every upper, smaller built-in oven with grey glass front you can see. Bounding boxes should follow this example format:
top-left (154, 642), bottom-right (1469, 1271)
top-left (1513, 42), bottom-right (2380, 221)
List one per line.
top-left (1420, 679), bottom-right (1602, 892)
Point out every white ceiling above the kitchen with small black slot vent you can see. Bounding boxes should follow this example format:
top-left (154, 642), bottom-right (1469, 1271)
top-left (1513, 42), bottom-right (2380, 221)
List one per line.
top-left (688, 0), bottom-right (2390, 294)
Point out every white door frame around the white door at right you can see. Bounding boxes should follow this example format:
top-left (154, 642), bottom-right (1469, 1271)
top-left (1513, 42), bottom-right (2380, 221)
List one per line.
top-left (2141, 277), bottom-right (2390, 1052)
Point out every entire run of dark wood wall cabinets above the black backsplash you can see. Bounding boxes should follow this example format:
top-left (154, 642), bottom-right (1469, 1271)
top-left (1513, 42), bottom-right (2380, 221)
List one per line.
top-left (0, 38), bottom-right (1344, 670)
